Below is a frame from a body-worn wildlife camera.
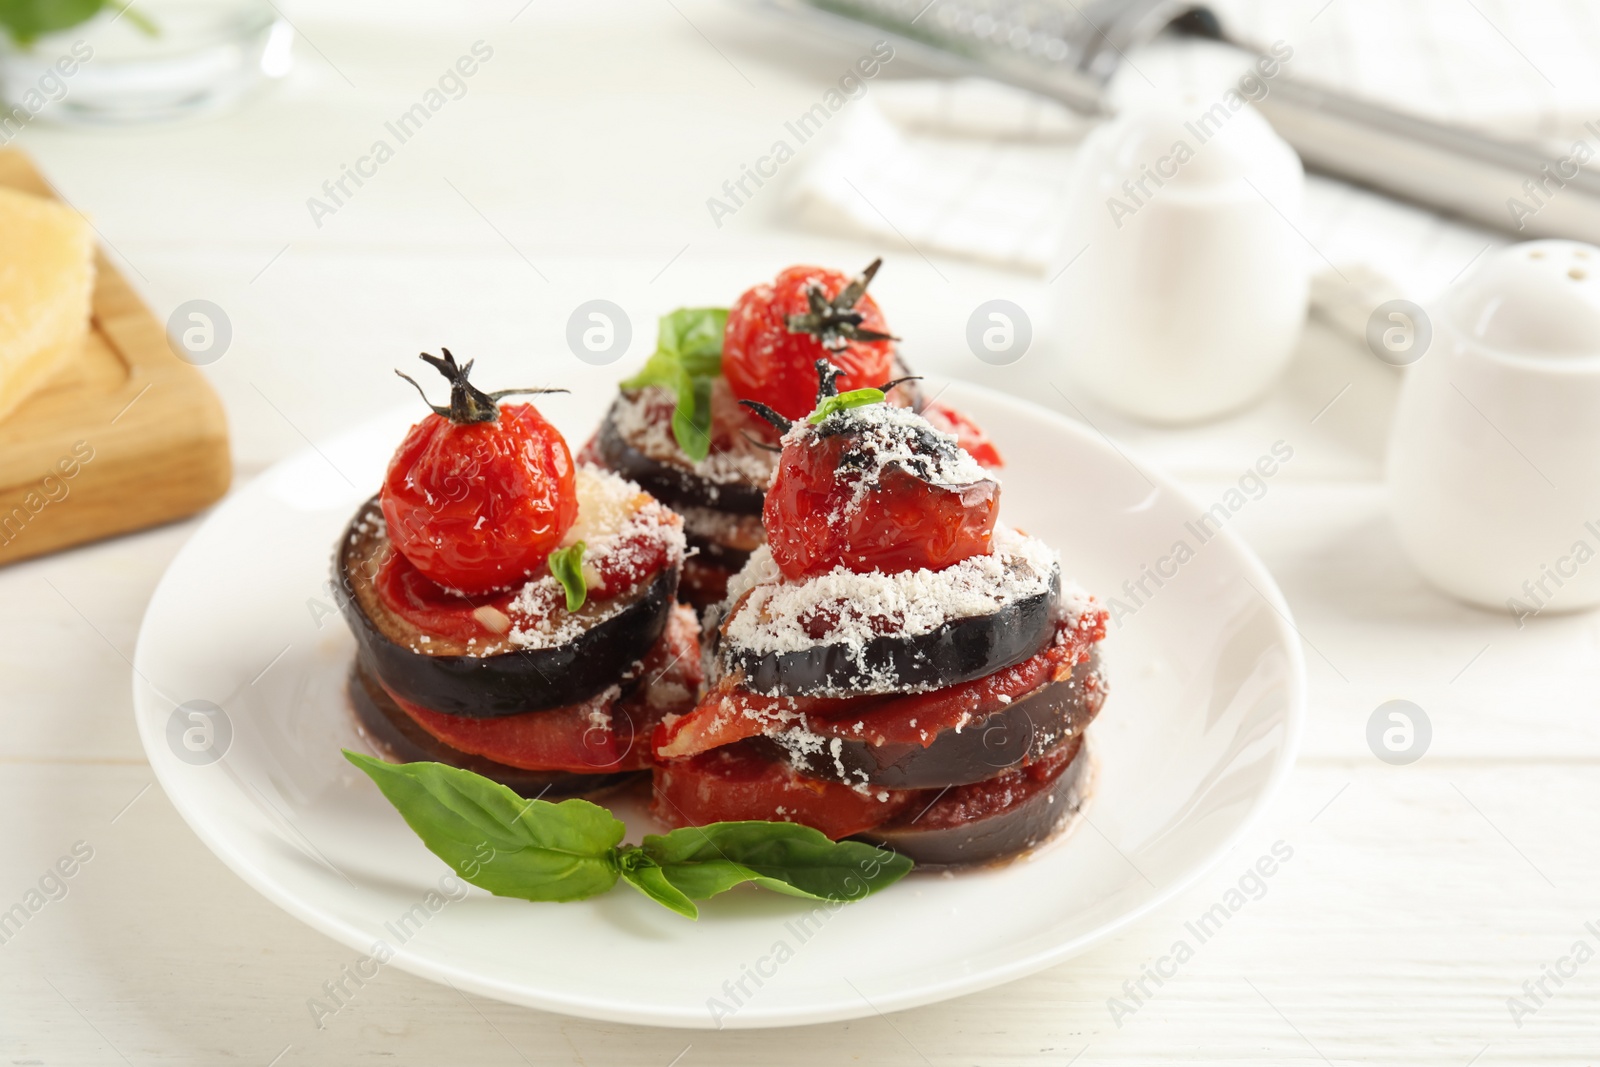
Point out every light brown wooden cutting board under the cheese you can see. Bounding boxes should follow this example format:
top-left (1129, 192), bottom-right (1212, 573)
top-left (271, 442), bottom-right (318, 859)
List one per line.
top-left (0, 149), bottom-right (234, 563)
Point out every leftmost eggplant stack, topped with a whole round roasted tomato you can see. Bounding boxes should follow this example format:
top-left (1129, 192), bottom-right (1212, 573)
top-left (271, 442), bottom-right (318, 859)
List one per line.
top-left (334, 350), bottom-right (702, 797)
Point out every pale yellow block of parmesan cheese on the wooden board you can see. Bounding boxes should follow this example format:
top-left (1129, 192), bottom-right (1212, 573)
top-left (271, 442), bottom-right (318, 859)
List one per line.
top-left (0, 189), bottom-right (94, 419)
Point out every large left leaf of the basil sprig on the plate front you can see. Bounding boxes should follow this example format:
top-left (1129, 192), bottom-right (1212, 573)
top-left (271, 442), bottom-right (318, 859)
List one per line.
top-left (344, 749), bottom-right (624, 901)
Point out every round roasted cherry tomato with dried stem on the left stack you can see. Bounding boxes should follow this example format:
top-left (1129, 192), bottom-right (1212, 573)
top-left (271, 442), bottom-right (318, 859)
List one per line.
top-left (381, 349), bottom-right (578, 597)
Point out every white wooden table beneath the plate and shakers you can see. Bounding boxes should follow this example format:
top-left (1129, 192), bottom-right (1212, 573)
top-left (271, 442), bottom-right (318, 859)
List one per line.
top-left (0, 0), bottom-right (1600, 1067)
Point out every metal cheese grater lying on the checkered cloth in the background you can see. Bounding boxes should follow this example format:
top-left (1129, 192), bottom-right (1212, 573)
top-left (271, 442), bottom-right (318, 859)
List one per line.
top-left (763, 0), bottom-right (1600, 243)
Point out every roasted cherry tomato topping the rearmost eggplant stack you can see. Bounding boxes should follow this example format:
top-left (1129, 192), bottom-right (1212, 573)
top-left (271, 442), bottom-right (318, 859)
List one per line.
top-left (722, 259), bottom-right (894, 419)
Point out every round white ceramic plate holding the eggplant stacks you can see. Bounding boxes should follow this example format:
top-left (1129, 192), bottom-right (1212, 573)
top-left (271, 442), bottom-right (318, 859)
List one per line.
top-left (134, 384), bottom-right (1304, 1027)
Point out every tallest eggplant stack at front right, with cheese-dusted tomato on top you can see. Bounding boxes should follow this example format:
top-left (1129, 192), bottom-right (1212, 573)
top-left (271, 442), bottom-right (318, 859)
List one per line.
top-left (653, 362), bottom-right (1106, 867)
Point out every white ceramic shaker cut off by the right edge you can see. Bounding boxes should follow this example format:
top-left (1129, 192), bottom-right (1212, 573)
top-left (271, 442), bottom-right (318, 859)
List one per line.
top-left (1389, 240), bottom-right (1600, 621)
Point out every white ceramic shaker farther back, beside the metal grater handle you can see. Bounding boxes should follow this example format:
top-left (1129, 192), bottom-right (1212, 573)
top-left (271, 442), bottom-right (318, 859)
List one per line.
top-left (1051, 98), bottom-right (1309, 422)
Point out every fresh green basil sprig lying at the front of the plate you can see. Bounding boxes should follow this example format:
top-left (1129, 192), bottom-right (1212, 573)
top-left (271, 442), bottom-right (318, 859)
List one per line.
top-left (344, 749), bottom-right (912, 918)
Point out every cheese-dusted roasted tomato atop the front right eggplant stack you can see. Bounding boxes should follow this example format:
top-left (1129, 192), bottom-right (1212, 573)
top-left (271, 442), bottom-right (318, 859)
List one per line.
top-left (762, 411), bottom-right (1000, 579)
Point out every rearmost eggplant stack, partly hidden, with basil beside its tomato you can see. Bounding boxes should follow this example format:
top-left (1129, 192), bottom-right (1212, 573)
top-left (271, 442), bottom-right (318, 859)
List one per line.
top-left (582, 259), bottom-right (1000, 608)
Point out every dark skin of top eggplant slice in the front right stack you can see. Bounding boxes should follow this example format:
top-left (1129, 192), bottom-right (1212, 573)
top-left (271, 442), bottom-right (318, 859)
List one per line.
top-left (729, 571), bottom-right (1061, 696)
